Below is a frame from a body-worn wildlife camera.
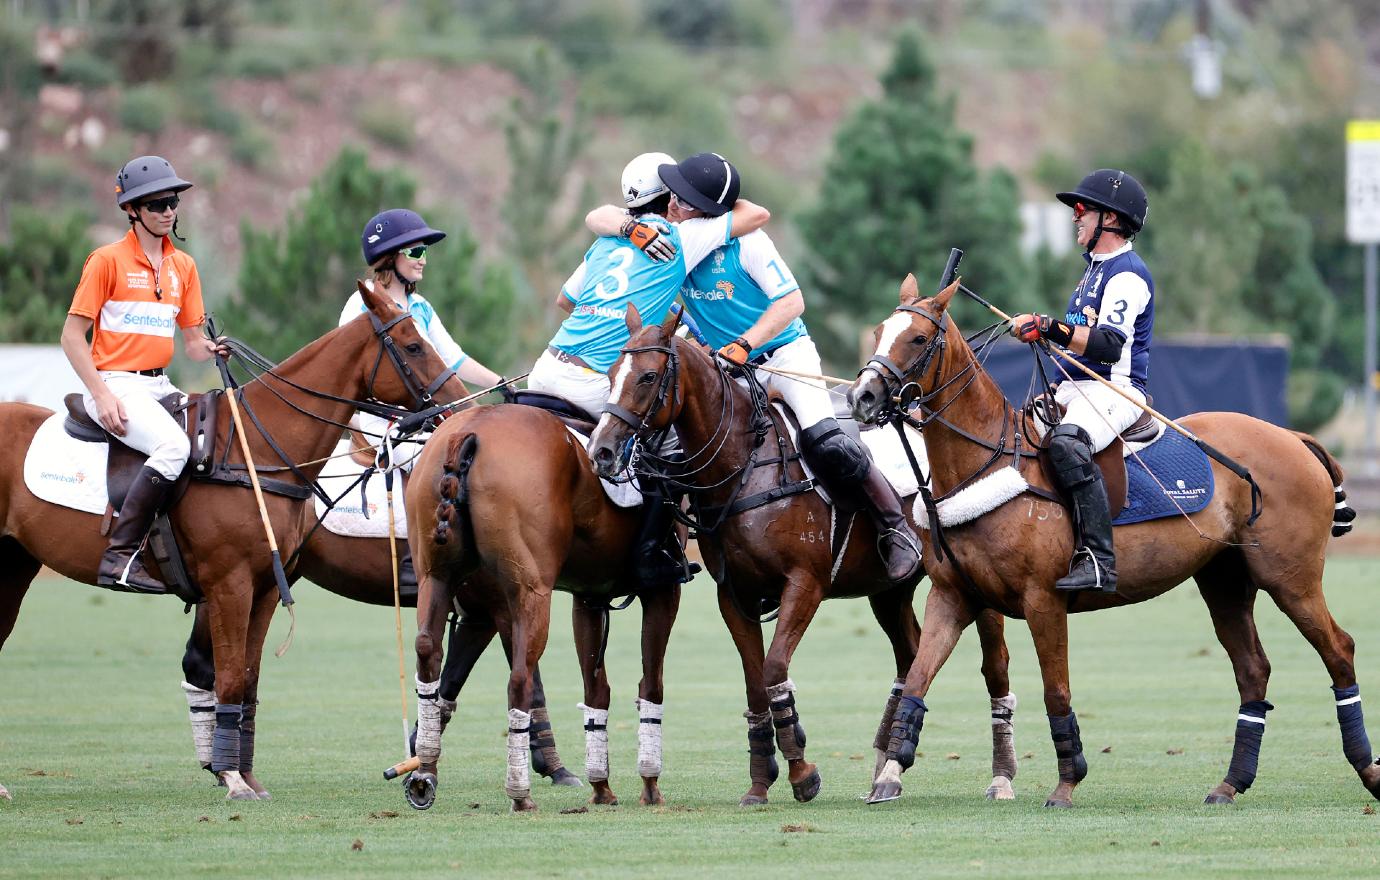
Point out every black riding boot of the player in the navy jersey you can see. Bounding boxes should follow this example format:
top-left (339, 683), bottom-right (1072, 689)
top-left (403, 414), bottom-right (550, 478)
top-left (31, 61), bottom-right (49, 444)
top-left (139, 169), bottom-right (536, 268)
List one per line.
top-left (1049, 425), bottom-right (1116, 593)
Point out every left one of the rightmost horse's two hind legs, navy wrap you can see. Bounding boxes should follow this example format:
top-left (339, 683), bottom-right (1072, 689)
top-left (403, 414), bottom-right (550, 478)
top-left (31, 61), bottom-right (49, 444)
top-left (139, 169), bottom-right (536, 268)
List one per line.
top-left (1194, 552), bottom-right (1274, 804)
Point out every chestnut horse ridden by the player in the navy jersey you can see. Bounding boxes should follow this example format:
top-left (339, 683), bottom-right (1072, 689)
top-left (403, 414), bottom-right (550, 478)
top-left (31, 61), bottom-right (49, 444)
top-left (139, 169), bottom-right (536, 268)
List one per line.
top-left (849, 276), bottom-right (1380, 807)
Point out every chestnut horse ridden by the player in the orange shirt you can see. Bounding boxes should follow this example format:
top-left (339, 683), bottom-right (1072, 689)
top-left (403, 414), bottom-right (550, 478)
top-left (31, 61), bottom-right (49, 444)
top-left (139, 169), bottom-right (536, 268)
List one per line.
top-left (0, 284), bottom-right (465, 800)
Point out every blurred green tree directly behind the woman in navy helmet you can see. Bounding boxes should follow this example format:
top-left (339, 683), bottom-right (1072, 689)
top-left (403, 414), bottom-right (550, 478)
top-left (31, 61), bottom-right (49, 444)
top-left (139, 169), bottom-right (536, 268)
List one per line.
top-left (226, 148), bottom-right (516, 368)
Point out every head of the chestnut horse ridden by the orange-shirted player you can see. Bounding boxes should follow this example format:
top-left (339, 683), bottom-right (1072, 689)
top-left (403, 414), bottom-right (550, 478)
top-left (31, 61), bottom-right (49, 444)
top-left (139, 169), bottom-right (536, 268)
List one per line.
top-left (356, 281), bottom-right (465, 411)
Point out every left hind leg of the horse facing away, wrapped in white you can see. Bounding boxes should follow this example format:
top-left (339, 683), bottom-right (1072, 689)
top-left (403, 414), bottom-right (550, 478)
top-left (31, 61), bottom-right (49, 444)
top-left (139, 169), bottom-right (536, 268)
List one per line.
top-left (403, 573), bottom-right (451, 810)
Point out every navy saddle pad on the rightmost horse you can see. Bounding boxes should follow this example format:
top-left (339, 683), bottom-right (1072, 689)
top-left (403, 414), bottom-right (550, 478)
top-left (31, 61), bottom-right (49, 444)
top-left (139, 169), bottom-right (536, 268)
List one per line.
top-left (1112, 428), bottom-right (1213, 526)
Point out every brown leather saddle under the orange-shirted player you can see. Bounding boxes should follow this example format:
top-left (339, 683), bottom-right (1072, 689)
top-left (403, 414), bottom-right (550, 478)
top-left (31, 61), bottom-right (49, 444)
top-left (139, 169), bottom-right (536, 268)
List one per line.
top-left (62, 390), bottom-right (221, 604)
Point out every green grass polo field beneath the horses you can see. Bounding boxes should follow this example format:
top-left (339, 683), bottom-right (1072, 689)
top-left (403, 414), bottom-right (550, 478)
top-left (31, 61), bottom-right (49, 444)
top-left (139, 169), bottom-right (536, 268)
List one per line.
top-left (0, 557), bottom-right (1380, 879)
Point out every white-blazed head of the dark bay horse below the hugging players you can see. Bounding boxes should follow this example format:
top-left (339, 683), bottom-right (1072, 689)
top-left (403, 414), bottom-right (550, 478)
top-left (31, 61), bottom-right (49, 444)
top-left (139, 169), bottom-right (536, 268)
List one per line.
top-left (589, 305), bottom-right (684, 477)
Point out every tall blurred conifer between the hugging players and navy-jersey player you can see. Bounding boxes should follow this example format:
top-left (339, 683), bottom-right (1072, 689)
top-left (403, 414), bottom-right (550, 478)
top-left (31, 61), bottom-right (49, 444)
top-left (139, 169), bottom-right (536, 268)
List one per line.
top-left (800, 32), bottom-right (1023, 364)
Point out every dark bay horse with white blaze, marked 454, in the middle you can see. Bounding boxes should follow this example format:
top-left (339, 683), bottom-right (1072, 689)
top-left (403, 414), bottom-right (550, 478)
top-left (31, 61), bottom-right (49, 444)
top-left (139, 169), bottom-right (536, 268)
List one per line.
top-left (589, 306), bottom-right (1016, 806)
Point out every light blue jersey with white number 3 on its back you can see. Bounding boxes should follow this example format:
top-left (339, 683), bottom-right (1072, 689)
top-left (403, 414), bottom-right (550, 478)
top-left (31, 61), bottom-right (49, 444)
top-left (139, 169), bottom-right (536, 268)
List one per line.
top-left (551, 211), bottom-right (733, 372)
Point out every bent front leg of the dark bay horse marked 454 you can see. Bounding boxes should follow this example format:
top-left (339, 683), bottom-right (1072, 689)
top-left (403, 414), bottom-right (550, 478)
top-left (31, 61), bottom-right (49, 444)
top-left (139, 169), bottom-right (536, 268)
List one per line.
top-left (762, 575), bottom-right (822, 803)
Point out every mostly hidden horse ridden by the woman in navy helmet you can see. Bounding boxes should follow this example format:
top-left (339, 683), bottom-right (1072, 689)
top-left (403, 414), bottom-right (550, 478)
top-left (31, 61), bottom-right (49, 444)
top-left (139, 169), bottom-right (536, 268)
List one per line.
top-left (182, 506), bottom-right (580, 796)
